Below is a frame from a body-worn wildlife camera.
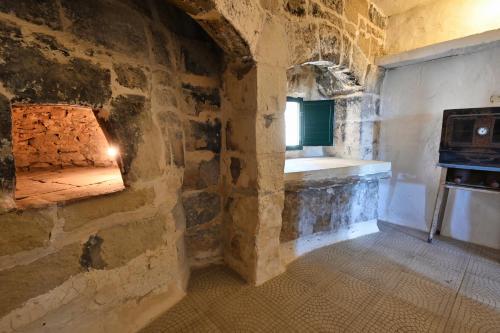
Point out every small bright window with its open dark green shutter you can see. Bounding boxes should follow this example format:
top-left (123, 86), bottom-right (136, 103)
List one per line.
top-left (285, 97), bottom-right (334, 150)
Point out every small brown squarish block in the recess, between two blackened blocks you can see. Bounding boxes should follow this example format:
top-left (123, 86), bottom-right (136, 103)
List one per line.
top-left (182, 155), bottom-right (220, 190)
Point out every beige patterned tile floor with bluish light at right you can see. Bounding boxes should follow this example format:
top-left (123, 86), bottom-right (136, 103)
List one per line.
top-left (143, 224), bottom-right (500, 333)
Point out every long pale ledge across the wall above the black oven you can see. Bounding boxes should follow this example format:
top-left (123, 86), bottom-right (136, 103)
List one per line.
top-left (375, 29), bottom-right (500, 69)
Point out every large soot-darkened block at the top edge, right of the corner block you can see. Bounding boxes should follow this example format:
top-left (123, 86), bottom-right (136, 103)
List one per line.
top-left (61, 0), bottom-right (148, 56)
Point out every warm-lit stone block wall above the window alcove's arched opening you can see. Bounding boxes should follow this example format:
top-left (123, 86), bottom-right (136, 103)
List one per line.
top-left (280, 0), bottom-right (387, 85)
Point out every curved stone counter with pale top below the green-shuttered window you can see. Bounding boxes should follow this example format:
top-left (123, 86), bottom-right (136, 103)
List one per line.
top-left (280, 158), bottom-right (391, 263)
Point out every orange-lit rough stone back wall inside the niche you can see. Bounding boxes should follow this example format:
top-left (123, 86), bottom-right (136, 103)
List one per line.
top-left (12, 105), bottom-right (114, 171)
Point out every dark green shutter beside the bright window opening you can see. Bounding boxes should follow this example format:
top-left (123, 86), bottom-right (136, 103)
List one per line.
top-left (302, 101), bottom-right (334, 146)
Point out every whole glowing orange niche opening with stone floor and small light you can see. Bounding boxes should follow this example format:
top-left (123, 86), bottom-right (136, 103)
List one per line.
top-left (12, 104), bottom-right (124, 209)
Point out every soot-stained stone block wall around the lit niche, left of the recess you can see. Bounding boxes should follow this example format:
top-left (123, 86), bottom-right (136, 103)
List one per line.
top-left (0, 0), bottom-right (222, 332)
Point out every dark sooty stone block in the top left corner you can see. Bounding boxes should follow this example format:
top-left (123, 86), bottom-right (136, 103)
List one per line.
top-left (0, 0), bottom-right (62, 30)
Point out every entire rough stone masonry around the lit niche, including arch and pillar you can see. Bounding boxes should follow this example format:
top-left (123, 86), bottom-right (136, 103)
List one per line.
top-left (0, 0), bottom-right (385, 332)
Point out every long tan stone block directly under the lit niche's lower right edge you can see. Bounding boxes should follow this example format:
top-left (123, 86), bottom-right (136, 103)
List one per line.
top-left (57, 189), bottom-right (155, 231)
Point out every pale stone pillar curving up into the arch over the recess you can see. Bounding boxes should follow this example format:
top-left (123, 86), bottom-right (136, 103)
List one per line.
top-left (166, 0), bottom-right (286, 284)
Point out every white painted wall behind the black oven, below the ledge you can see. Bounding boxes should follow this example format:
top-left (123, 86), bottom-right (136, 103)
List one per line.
top-left (379, 47), bottom-right (500, 248)
